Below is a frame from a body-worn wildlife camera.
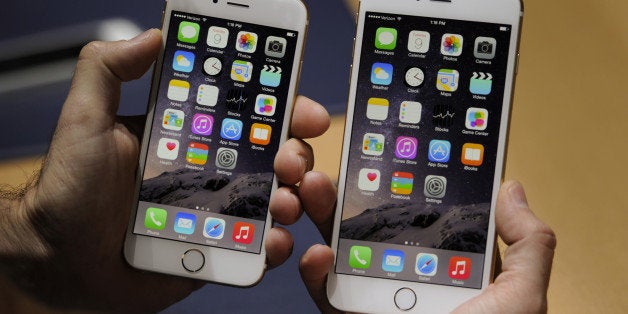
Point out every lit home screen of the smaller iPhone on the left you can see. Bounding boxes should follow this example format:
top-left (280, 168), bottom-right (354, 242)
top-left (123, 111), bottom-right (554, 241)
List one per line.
top-left (133, 11), bottom-right (299, 253)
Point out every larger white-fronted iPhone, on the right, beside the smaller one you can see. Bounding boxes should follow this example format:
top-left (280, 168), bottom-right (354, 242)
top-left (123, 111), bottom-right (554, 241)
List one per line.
top-left (327, 0), bottom-right (523, 313)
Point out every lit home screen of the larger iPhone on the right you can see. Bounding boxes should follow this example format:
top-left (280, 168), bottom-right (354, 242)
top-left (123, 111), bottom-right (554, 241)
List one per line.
top-left (336, 12), bottom-right (512, 288)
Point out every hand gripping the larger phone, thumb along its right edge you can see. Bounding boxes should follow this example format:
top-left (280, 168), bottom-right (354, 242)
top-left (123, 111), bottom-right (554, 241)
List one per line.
top-left (299, 181), bottom-right (556, 313)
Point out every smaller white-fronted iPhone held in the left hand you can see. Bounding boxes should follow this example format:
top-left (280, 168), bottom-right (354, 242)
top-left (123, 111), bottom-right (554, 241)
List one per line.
top-left (124, 0), bottom-right (308, 286)
